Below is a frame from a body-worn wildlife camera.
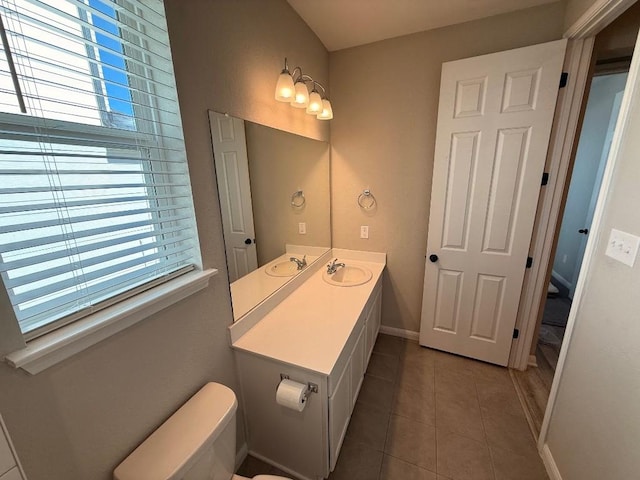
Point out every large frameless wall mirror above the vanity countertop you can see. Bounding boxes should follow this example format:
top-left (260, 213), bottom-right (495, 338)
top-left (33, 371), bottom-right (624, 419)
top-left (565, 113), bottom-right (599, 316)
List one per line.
top-left (209, 111), bottom-right (331, 321)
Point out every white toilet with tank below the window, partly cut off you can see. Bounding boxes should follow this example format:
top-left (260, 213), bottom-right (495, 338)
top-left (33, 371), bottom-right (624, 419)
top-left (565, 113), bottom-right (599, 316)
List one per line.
top-left (113, 383), bottom-right (290, 480)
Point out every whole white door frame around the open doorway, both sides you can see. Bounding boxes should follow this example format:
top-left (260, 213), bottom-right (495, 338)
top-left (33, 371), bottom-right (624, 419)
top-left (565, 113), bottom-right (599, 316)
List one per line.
top-left (502, 0), bottom-right (640, 464)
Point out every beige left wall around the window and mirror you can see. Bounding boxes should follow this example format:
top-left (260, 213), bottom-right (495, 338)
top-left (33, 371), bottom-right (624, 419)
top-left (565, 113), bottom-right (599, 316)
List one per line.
top-left (0, 0), bottom-right (328, 480)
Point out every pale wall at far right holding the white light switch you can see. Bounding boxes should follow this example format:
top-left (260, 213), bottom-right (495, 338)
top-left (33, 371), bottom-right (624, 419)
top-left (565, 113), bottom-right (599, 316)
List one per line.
top-left (547, 42), bottom-right (640, 480)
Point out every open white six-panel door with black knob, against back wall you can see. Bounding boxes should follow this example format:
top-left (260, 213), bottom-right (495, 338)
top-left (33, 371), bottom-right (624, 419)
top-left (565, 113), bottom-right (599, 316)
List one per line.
top-left (420, 40), bottom-right (566, 365)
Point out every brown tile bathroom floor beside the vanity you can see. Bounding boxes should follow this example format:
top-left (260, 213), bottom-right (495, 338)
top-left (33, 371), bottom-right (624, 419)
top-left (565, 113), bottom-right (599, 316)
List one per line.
top-left (238, 334), bottom-right (548, 480)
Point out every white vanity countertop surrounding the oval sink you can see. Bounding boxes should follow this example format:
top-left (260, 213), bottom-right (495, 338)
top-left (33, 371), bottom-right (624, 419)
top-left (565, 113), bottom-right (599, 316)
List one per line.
top-left (233, 251), bottom-right (385, 375)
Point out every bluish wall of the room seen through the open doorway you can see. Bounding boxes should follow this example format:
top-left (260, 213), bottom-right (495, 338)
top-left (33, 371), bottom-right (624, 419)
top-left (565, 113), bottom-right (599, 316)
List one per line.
top-left (553, 73), bottom-right (627, 288)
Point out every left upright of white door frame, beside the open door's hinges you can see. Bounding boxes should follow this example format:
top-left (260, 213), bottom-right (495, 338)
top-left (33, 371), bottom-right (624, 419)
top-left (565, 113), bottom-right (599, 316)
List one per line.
top-left (509, 37), bottom-right (594, 370)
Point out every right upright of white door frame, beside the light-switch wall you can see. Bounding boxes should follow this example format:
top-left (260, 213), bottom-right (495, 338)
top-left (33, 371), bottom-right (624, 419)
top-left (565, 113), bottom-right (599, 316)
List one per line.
top-left (538, 27), bottom-right (640, 450)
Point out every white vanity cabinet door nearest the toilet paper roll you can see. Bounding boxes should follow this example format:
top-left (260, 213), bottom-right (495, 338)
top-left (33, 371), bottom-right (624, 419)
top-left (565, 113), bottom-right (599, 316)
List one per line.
top-left (329, 362), bottom-right (352, 471)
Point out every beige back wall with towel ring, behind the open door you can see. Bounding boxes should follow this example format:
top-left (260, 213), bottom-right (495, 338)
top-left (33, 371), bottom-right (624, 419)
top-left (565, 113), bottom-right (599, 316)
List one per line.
top-left (331, 3), bottom-right (564, 331)
